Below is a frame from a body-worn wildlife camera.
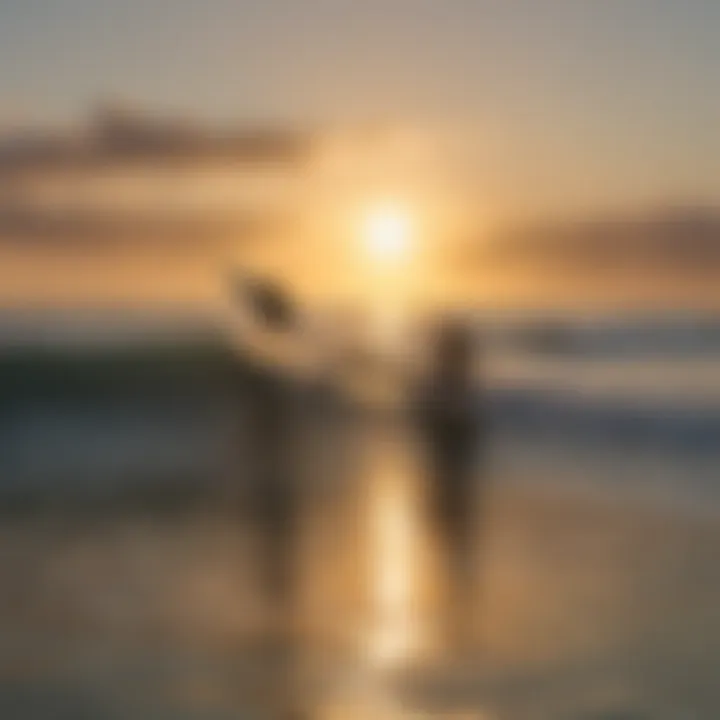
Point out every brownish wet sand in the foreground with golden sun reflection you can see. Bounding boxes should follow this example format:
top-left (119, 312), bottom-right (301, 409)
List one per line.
top-left (0, 420), bottom-right (720, 720)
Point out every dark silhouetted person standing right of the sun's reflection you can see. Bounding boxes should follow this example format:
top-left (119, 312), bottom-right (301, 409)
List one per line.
top-left (417, 322), bottom-right (484, 641)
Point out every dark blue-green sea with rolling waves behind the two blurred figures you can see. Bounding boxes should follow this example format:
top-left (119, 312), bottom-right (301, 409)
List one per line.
top-left (0, 316), bottom-right (720, 510)
